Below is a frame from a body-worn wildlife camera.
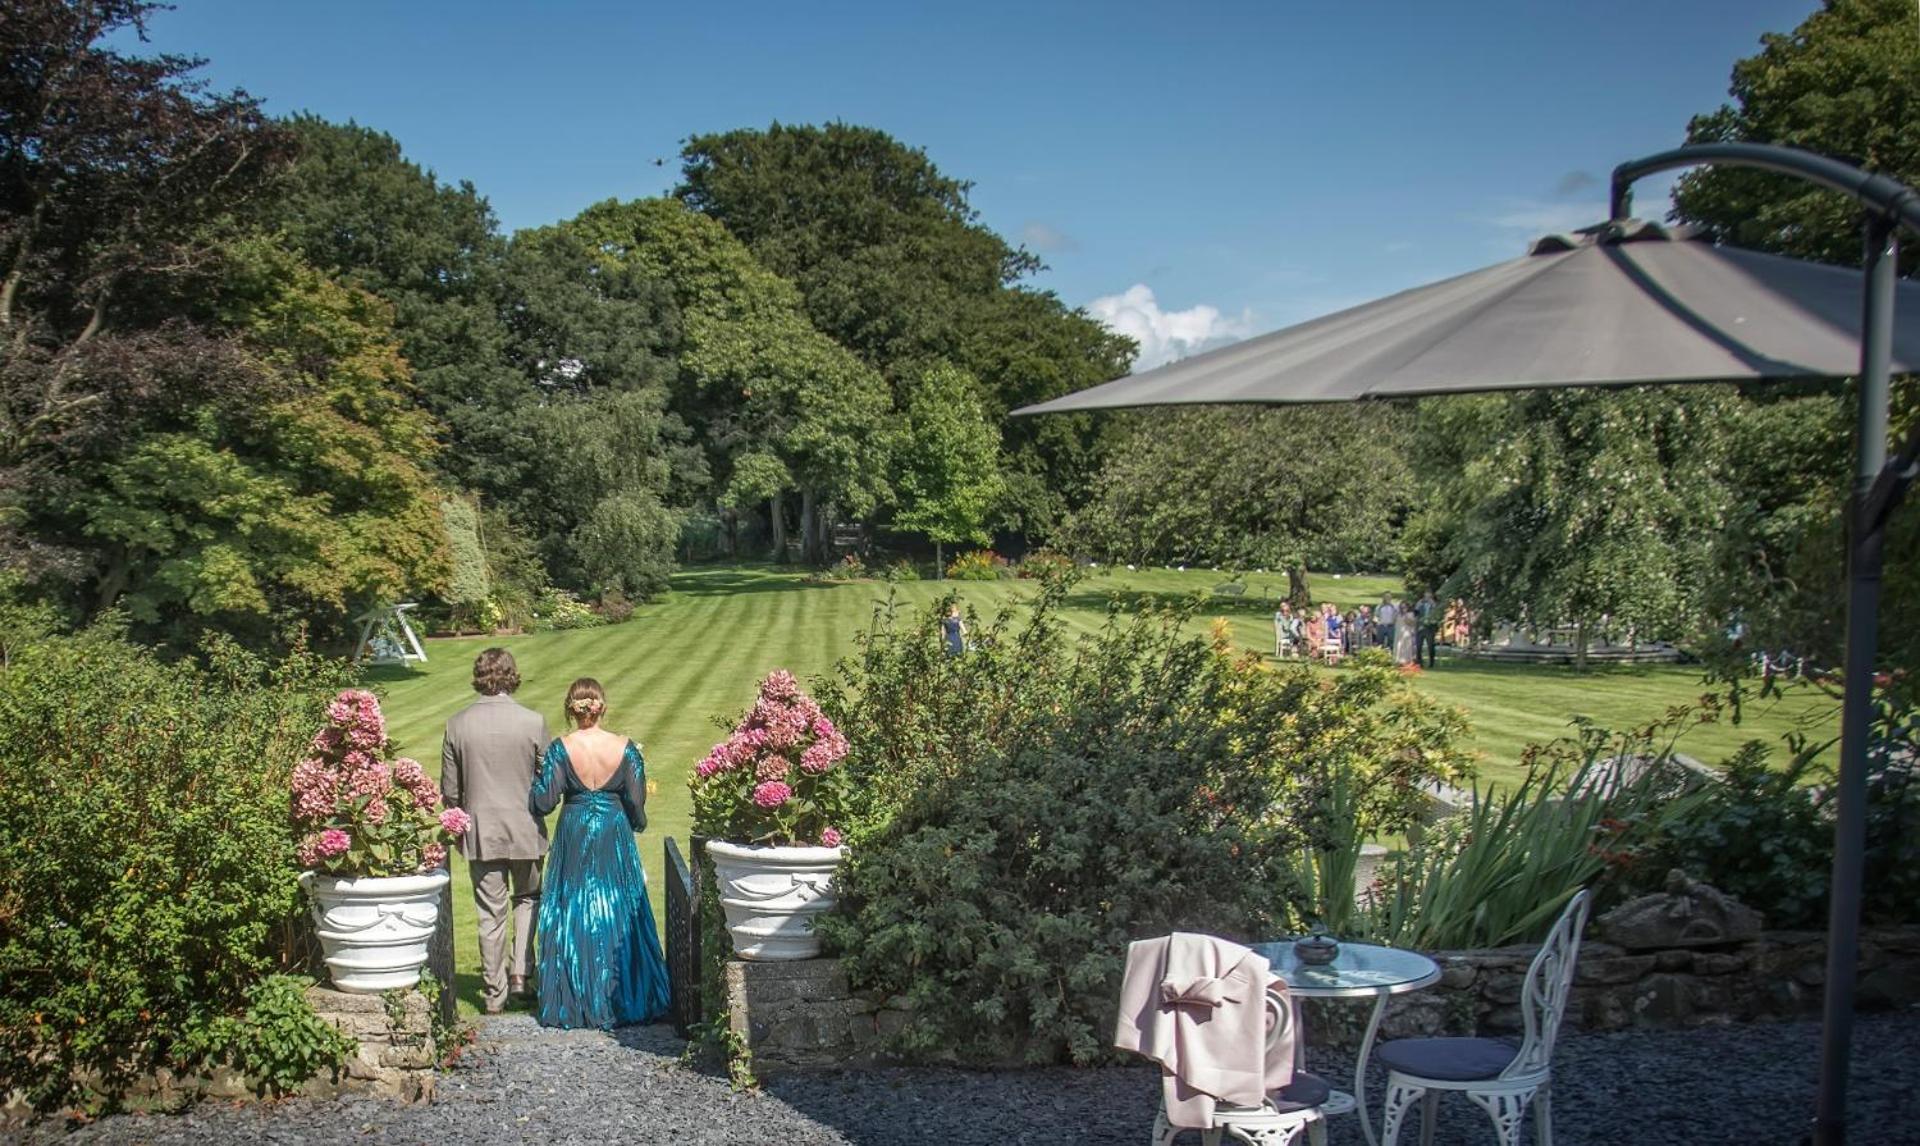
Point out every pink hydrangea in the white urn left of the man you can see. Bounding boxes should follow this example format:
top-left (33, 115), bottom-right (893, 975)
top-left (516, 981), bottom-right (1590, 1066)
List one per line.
top-left (292, 689), bottom-right (472, 875)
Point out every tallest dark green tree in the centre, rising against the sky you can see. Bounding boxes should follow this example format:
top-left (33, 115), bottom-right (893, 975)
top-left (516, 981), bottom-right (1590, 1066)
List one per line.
top-left (676, 123), bottom-right (1135, 534)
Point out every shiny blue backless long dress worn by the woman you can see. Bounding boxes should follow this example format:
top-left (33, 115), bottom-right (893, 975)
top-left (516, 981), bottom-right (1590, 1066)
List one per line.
top-left (528, 741), bottom-right (666, 1029)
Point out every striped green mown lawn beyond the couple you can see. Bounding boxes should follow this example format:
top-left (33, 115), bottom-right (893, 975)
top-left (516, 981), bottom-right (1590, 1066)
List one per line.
top-left (369, 568), bottom-right (1832, 1008)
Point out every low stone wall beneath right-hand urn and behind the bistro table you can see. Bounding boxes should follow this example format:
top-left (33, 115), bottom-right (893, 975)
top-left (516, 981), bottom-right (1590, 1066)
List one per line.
top-left (726, 927), bottom-right (1920, 1073)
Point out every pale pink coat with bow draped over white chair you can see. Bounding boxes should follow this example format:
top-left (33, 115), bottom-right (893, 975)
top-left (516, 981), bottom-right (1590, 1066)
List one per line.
top-left (1114, 931), bottom-right (1294, 1129)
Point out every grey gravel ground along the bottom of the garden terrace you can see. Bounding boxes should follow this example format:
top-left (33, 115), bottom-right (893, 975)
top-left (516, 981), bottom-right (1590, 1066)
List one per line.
top-left (29, 1010), bottom-right (1920, 1146)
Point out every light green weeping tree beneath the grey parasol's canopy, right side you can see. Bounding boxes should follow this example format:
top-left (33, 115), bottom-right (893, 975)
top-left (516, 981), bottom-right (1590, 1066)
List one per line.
top-left (1409, 388), bottom-right (1738, 668)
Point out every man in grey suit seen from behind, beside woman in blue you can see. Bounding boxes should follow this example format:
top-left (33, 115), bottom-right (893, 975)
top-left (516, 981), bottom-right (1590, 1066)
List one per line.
top-left (440, 649), bottom-right (547, 1015)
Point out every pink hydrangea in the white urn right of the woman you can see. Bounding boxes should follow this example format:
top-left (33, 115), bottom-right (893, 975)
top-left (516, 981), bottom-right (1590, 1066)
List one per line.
top-left (693, 670), bottom-right (849, 847)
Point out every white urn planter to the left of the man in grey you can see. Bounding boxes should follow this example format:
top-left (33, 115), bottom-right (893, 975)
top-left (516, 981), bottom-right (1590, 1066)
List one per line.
top-left (300, 868), bottom-right (451, 994)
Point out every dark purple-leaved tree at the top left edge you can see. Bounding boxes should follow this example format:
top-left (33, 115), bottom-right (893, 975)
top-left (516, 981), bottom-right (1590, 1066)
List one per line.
top-left (0, 0), bottom-right (290, 585)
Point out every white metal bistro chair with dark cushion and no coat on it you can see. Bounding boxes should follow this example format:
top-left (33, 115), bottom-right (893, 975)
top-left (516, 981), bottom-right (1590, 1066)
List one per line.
top-left (1375, 891), bottom-right (1590, 1146)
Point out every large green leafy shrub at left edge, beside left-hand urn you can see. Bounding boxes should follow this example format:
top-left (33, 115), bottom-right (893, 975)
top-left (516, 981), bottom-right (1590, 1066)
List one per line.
top-left (0, 628), bottom-right (359, 1110)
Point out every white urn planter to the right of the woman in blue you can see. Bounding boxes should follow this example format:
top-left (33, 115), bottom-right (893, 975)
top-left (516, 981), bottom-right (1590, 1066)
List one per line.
top-left (707, 841), bottom-right (847, 962)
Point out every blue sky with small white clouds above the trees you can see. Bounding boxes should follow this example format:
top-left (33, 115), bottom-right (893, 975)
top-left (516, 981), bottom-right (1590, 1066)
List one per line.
top-left (152, 0), bottom-right (1816, 361)
